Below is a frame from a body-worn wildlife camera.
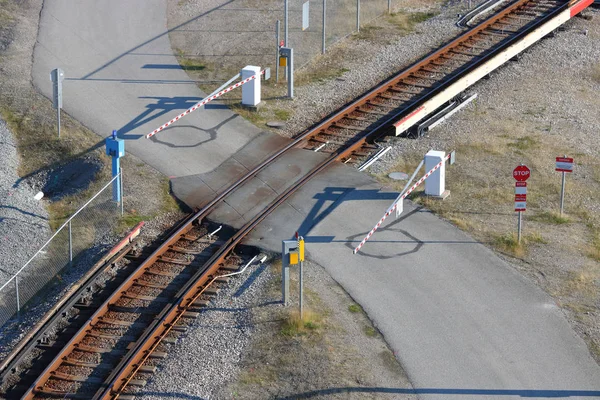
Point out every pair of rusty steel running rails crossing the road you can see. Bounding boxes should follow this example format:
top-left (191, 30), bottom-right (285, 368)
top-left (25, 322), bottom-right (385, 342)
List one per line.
top-left (21, 0), bottom-right (584, 398)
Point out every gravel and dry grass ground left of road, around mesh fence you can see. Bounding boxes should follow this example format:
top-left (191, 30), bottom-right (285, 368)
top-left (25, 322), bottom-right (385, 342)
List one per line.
top-left (0, 0), bottom-right (182, 358)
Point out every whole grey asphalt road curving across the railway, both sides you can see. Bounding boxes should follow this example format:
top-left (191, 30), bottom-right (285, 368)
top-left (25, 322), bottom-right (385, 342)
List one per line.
top-left (33, 0), bottom-right (600, 400)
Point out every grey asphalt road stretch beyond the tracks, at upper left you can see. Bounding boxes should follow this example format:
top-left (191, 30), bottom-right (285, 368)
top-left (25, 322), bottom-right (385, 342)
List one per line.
top-left (33, 0), bottom-right (261, 176)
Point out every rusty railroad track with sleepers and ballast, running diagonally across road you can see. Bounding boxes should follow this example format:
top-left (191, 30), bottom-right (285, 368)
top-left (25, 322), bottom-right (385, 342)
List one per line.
top-left (0, 0), bottom-right (591, 399)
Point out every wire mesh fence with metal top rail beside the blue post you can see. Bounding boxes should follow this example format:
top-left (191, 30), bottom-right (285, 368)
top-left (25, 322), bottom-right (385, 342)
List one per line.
top-left (0, 172), bottom-right (124, 326)
